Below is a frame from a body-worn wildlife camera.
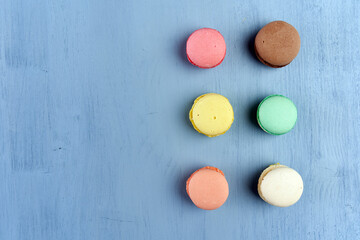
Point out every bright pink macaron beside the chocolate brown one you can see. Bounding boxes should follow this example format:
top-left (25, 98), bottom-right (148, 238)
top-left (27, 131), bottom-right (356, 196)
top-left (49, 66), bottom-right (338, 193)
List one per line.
top-left (186, 28), bottom-right (226, 68)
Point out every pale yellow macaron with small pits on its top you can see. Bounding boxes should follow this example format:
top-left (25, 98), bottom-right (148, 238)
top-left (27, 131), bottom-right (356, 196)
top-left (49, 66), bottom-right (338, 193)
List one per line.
top-left (189, 93), bottom-right (234, 137)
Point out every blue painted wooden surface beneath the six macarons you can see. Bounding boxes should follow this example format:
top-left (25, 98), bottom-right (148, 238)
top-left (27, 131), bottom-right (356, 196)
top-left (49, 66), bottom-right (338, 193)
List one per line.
top-left (0, 0), bottom-right (360, 240)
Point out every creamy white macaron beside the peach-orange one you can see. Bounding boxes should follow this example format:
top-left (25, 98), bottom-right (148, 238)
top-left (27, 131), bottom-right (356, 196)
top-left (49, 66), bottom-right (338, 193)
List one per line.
top-left (258, 164), bottom-right (304, 207)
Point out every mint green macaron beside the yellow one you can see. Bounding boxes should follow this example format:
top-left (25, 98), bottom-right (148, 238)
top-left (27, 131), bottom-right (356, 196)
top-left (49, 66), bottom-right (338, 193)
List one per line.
top-left (256, 95), bottom-right (297, 135)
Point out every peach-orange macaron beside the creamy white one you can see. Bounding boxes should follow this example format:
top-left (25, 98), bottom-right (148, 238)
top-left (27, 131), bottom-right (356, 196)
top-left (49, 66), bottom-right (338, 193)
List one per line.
top-left (186, 166), bottom-right (229, 210)
